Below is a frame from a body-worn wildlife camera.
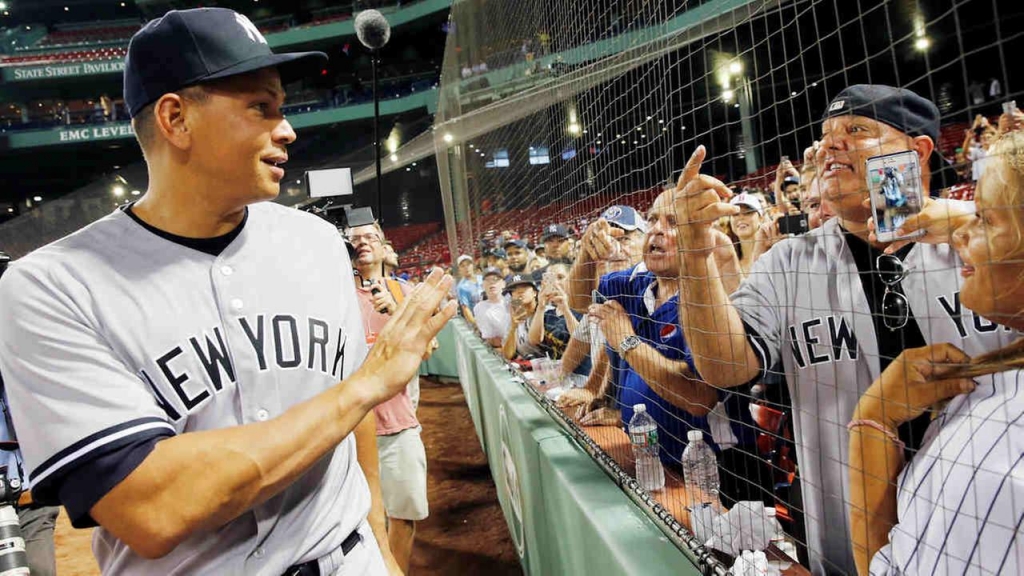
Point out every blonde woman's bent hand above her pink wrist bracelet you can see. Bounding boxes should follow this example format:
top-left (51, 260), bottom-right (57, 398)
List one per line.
top-left (854, 343), bottom-right (977, 429)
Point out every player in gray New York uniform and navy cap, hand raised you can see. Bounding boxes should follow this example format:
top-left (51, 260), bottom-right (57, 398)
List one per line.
top-left (0, 8), bottom-right (455, 576)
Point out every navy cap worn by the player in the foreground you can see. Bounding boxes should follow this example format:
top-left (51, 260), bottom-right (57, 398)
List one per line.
top-left (125, 8), bottom-right (327, 118)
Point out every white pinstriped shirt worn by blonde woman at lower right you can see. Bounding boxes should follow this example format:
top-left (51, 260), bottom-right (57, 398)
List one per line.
top-left (870, 371), bottom-right (1024, 575)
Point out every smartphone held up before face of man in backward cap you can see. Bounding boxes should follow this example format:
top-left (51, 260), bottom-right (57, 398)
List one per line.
top-left (867, 151), bottom-right (924, 242)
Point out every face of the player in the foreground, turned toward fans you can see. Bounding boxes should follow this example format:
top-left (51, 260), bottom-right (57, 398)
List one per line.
top-left (188, 68), bottom-right (296, 204)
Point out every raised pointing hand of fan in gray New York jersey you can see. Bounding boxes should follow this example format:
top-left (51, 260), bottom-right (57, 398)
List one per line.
top-left (673, 146), bottom-right (739, 256)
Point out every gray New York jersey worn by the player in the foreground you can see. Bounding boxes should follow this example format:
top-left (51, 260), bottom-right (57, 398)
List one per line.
top-left (0, 203), bottom-right (370, 576)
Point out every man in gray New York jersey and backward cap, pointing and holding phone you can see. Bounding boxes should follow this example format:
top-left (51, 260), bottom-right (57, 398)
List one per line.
top-left (676, 85), bottom-right (1014, 574)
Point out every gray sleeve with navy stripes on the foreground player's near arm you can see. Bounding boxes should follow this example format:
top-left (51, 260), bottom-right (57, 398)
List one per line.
top-left (0, 263), bottom-right (176, 504)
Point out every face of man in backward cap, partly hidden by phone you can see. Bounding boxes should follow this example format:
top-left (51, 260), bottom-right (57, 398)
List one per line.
top-left (815, 116), bottom-right (924, 222)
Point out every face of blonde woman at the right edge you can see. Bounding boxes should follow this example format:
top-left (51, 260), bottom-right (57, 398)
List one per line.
top-left (953, 160), bottom-right (1024, 328)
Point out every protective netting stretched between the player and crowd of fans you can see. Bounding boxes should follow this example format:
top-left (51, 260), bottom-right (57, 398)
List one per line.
top-left (430, 0), bottom-right (1024, 573)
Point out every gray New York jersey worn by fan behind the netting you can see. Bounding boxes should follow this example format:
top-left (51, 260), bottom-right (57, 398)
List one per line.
top-left (732, 219), bottom-right (1016, 574)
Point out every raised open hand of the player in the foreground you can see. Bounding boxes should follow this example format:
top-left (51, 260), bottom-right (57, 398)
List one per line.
top-left (359, 269), bottom-right (457, 404)
